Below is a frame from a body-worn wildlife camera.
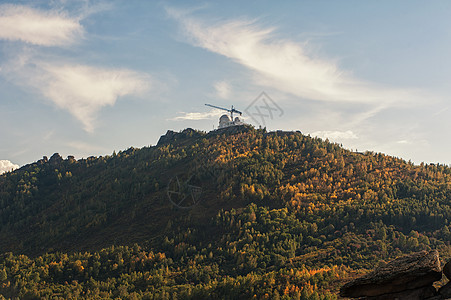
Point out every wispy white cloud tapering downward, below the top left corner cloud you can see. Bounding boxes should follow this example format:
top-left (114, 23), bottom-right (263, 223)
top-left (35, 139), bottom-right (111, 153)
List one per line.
top-left (2, 55), bottom-right (152, 132)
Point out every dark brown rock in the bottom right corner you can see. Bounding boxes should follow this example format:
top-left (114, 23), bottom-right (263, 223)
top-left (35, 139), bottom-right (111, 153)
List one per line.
top-left (340, 250), bottom-right (444, 300)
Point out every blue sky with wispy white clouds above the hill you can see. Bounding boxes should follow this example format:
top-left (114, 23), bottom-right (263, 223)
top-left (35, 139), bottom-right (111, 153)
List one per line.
top-left (0, 0), bottom-right (451, 173)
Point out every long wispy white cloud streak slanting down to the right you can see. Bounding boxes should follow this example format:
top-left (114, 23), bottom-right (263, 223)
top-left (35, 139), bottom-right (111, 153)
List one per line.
top-left (172, 14), bottom-right (420, 108)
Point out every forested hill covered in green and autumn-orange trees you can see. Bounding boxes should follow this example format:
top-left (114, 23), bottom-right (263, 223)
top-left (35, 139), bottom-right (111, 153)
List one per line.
top-left (0, 127), bottom-right (451, 299)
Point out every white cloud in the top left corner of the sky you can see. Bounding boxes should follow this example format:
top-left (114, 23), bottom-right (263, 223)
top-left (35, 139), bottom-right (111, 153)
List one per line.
top-left (0, 4), bottom-right (84, 46)
